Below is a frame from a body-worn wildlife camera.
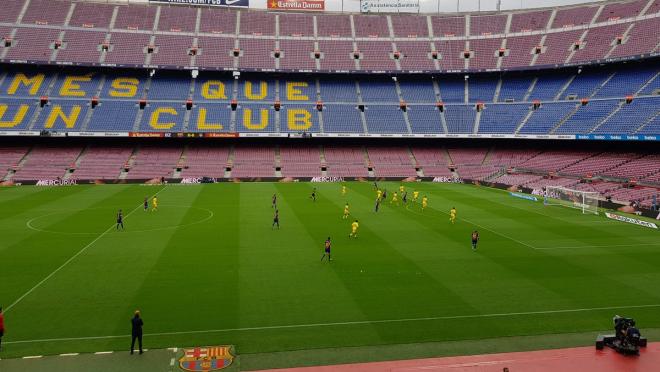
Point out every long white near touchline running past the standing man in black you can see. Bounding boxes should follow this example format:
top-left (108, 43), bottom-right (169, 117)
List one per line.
top-left (5, 304), bottom-right (660, 344)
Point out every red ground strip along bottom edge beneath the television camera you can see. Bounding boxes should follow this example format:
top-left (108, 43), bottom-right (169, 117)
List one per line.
top-left (258, 342), bottom-right (660, 372)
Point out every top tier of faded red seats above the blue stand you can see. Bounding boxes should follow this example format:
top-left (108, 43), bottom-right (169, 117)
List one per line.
top-left (0, 0), bottom-right (660, 73)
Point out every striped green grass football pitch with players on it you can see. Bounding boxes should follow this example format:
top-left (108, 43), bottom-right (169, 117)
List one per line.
top-left (0, 182), bottom-right (660, 364)
